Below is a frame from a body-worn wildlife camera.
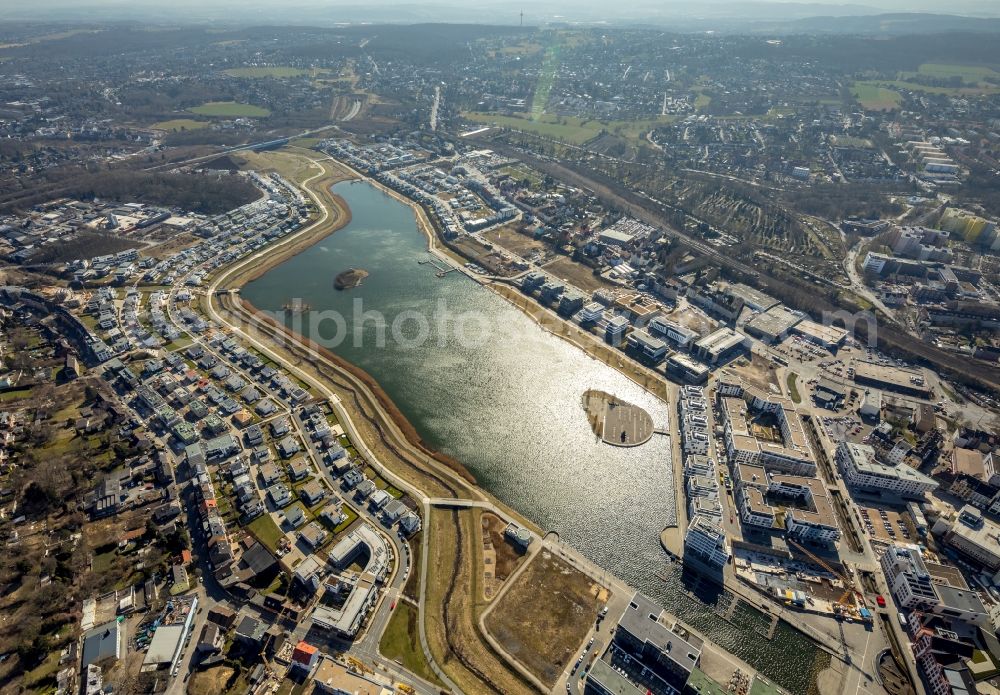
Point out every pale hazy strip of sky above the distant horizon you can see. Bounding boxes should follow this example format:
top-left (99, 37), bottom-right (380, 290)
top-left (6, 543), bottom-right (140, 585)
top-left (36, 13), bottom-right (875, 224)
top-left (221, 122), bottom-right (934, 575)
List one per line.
top-left (0, 0), bottom-right (1000, 24)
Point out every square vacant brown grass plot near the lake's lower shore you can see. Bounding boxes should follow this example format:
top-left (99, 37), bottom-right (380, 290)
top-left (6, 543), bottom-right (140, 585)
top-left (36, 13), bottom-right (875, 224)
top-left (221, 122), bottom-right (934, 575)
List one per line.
top-left (486, 550), bottom-right (606, 686)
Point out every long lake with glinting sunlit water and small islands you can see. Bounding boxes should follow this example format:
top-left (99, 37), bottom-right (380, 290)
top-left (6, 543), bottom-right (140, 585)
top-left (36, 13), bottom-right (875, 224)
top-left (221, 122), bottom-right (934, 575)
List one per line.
top-left (242, 182), bottom-right (825, 693)
